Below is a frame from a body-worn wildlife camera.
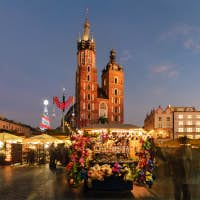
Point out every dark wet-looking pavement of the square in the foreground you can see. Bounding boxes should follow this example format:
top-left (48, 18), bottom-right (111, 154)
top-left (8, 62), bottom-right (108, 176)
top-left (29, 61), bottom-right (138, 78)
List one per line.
top-left (0, 165), bottom-right (199, 200)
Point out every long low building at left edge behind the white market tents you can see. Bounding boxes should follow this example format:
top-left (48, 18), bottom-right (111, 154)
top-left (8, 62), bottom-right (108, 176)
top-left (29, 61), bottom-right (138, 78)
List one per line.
top-left (0, 117), bottom-right (31, 136)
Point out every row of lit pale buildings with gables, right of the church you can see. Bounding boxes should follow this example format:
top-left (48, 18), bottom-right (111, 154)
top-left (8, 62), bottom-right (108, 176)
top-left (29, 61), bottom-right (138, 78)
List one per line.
top-left (144, 105), bottom-right (200, 139)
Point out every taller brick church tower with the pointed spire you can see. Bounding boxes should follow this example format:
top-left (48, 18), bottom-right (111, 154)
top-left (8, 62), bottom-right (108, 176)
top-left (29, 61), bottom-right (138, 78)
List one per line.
top-left (76, 13), bottom-right (98, 126)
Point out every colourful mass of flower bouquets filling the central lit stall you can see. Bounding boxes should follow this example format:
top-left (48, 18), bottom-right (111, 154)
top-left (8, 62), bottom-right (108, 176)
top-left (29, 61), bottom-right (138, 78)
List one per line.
top-left (66, 132), bottom-right (155, 188)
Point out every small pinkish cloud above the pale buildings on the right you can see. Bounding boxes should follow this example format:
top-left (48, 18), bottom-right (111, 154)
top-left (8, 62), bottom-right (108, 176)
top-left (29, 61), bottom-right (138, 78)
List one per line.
top-left (150, 65), bottom-right (178, 78)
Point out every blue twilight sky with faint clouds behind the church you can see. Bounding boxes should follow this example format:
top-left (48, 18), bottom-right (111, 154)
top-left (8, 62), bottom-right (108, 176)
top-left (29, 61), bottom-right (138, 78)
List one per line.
top-left (0, 0), bottom-right (200, 127)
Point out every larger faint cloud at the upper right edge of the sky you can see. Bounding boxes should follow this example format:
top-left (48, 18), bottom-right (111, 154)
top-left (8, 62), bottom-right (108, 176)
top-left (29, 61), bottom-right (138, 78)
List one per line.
top-left (160, 24), bottom-right (200, 52)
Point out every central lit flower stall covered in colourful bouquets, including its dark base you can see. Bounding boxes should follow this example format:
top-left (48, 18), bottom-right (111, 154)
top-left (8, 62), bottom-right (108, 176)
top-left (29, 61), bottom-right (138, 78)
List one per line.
top-left (66, 126), bottom-right (155, 190)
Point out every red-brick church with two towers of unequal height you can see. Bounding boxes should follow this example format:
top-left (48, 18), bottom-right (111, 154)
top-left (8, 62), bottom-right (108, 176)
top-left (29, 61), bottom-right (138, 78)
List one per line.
top-left (75, 14), bottom-right (124, 127)
